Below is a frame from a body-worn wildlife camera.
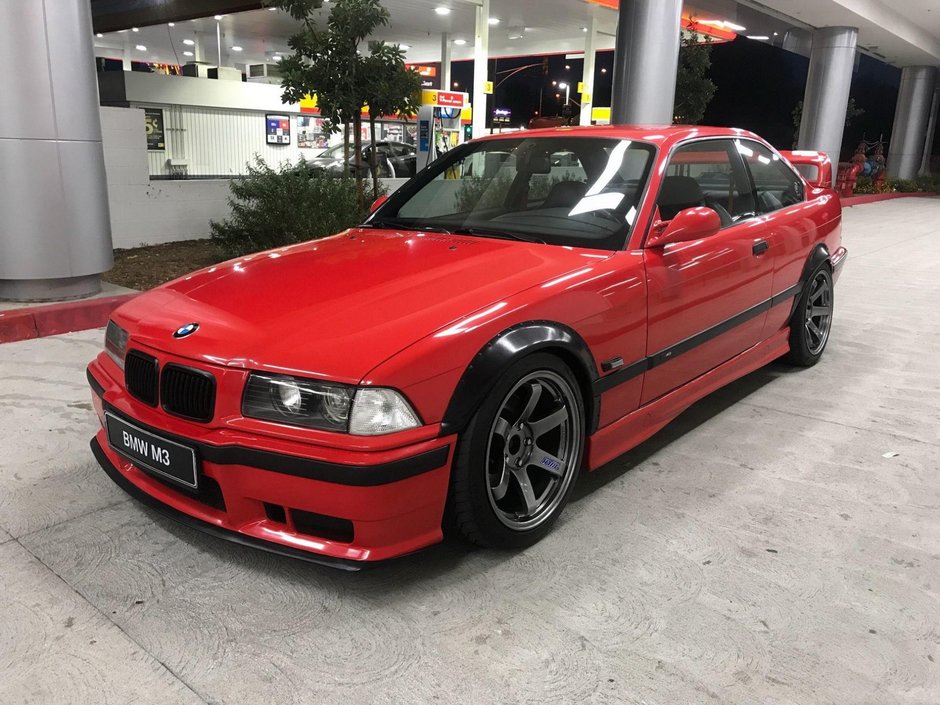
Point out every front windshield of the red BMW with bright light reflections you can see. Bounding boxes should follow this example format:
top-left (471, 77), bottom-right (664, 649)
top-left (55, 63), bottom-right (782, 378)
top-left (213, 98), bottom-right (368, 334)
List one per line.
top-left (367, 135), bottom-right (654, 250)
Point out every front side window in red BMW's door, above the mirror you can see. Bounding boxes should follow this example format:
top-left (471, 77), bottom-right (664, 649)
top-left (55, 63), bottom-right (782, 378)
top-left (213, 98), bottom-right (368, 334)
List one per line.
top-left (656, 140), bottom-right (754, 228)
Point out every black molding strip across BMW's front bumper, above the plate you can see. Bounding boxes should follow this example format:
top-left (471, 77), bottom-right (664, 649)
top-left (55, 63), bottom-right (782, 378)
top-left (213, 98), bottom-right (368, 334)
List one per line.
top-left (88, 372), bottom-right (450, 487)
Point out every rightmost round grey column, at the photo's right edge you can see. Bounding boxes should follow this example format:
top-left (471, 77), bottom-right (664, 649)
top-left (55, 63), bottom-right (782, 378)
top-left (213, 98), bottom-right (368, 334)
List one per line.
top-left (888, 66), bottom-right (937, 179)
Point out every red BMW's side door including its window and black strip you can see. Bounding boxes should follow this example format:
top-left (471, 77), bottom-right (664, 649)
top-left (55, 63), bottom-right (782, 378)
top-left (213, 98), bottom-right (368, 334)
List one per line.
top-left (641, 139), bottom-right (773, 404)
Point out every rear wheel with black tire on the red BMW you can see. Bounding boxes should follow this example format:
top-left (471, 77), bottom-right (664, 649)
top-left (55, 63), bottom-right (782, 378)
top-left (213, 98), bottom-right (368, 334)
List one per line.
top-left (786, 262), bottom-right (835, 367)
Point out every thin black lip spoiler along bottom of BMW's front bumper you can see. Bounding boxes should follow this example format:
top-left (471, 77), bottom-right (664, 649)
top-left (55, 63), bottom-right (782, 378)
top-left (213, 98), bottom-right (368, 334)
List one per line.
top-left (91, 438), bottom-right (380, 571)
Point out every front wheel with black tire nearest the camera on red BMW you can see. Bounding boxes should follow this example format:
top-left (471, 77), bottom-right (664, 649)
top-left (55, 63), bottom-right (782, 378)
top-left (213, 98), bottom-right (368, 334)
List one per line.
top-left (448, 353), bottom-right (584, 548)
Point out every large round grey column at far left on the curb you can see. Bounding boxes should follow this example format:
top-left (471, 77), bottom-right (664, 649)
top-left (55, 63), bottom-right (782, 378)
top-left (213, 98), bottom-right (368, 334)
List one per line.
top-left (0, 0), bottom-right (112, 300)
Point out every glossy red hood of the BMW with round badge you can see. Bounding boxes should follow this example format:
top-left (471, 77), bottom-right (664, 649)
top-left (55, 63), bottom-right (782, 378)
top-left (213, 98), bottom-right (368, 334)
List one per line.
top-left (115, 229), bottom-right (597, 383)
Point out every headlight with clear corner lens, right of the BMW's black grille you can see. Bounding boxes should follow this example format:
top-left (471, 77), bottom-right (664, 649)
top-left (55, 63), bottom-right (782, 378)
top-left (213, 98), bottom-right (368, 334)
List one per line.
top-left (242, 372), bottom-right (421, 436)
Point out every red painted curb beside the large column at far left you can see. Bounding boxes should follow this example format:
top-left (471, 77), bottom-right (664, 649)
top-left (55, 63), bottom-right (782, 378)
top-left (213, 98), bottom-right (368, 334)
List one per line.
top-left (0, 293), bottom-right (137, 343)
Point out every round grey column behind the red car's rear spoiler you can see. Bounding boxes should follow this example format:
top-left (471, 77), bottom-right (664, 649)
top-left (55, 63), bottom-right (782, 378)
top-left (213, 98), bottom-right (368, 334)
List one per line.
top-left (797, 27), bottom-right (858, 182)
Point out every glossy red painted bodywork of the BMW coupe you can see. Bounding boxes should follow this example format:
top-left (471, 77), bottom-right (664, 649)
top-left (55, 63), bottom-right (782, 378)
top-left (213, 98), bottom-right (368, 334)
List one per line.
top-left (91, 126), bottom-right (844, 560)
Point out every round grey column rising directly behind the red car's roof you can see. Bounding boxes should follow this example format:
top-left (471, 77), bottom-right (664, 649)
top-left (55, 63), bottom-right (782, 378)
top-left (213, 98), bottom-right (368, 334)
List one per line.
top-left (611, 0), bottom-right (682, 125)
